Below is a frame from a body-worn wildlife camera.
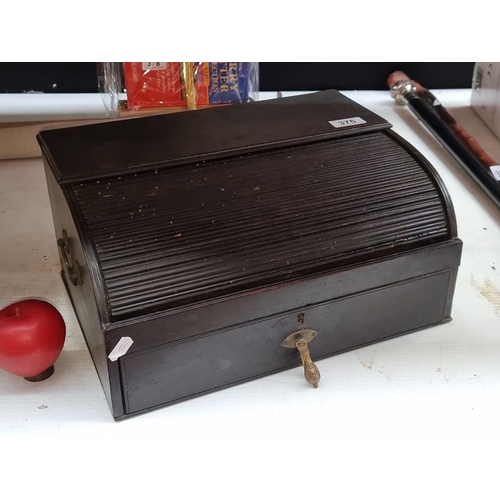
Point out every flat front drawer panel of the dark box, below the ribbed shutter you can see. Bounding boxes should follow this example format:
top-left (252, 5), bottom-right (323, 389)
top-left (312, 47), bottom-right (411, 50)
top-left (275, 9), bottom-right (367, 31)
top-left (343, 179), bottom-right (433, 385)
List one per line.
top-left (120, 269), bottom-right (452, 414)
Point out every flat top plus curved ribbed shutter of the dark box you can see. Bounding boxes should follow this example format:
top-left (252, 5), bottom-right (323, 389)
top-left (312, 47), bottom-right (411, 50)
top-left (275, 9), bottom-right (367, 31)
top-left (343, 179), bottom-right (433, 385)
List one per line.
top-left (36, 92), bottom-right (456, 321)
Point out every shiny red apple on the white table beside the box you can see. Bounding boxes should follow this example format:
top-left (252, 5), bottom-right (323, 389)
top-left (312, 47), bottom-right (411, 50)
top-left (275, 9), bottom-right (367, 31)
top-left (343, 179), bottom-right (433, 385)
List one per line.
top-left (0, 299), bottom-right (66, 381)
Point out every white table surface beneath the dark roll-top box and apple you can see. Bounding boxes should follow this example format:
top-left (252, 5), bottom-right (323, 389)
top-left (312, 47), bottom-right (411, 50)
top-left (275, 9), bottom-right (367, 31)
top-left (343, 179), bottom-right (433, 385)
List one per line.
top-left (0, 90), bottom-right (500, 499)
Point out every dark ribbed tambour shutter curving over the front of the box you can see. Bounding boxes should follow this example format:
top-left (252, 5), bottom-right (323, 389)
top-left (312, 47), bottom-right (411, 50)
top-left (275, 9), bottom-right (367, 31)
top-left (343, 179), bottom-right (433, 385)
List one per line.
top-left (72, 132), bottom-right (449, 319)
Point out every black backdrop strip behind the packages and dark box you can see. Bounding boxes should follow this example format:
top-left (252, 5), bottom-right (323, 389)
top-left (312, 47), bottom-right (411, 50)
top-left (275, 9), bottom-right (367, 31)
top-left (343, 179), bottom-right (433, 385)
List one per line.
top-left (0, 62), bottom-right (474, 93)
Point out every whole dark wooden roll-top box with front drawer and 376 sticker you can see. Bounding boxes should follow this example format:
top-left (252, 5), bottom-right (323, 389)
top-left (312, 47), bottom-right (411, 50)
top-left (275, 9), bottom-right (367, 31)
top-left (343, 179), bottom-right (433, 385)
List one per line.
top-left (38, 90), bottom-right (462, 419)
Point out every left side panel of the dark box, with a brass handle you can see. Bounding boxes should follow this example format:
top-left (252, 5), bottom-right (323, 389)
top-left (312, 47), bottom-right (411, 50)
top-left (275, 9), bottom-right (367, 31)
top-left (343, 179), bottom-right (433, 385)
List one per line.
top-left (44, 165), bottom-right (123, 416)
